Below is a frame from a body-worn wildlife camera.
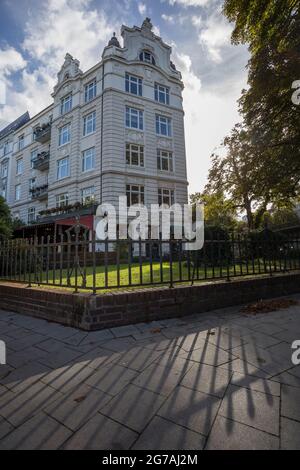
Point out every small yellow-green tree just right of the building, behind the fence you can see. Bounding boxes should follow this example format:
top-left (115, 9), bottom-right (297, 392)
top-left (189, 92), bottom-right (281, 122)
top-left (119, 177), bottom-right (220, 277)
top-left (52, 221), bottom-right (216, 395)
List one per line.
top-left (190, 191), bottom-right (237, 229)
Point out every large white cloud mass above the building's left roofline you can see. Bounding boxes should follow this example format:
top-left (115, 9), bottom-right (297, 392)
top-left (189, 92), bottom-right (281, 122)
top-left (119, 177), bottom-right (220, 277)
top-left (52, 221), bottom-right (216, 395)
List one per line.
top-left (0, 0), bottom-right (120, 122)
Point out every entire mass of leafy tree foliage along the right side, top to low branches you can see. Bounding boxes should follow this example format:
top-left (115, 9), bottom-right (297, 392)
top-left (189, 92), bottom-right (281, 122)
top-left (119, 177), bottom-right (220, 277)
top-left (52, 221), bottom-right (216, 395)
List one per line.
top-left (206, 0), bottom-right (300, 228)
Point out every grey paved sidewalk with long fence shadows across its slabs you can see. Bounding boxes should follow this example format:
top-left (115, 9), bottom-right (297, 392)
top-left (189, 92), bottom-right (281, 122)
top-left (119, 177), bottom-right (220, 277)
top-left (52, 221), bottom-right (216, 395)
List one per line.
top-left (0, 295), bottom-right (300, 450)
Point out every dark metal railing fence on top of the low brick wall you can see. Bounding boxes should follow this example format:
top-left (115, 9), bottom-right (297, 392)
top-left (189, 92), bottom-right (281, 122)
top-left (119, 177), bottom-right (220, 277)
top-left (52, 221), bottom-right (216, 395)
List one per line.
top-left (0, 223), bottom-right (300, 293)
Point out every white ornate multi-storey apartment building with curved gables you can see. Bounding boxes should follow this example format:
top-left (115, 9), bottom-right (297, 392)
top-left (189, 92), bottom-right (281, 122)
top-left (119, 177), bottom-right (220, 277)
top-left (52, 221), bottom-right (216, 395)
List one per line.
top-left (0, 18), bottom-right (187, 239)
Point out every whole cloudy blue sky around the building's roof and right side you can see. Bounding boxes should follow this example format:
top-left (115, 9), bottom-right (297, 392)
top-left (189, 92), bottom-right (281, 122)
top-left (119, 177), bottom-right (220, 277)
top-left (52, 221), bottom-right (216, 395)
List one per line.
top-left (0, 0), bottom-right (249, 194)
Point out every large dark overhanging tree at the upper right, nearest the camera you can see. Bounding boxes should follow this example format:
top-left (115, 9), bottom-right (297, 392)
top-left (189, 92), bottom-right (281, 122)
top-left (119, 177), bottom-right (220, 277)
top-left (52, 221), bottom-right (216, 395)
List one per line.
top-left (223, 0), bottom-right (300, 202)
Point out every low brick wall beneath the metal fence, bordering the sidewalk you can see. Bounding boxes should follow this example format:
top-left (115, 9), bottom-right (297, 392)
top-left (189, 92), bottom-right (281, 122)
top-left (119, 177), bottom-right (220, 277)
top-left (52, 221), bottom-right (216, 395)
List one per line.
top-left (0, 273), bottom-right (300, 330)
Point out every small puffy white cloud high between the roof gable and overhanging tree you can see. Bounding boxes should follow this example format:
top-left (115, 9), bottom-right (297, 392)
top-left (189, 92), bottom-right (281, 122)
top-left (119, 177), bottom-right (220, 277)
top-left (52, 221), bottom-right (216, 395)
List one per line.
top-left (199, 13), bottom-right (233, 63)
